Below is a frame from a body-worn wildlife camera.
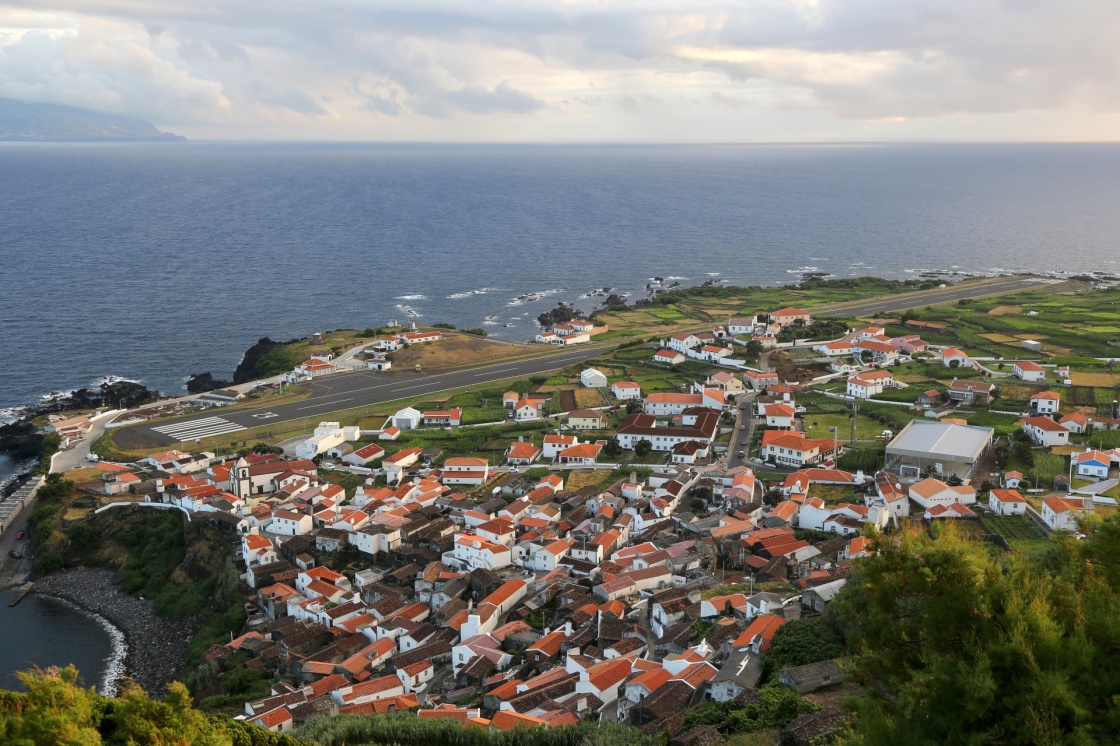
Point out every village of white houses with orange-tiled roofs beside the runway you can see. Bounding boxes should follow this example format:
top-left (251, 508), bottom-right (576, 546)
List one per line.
top-left (6, 275), bottom-right (1120, 745)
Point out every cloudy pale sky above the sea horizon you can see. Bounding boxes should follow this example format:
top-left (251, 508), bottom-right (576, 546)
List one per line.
top-left (0, 0), bottom-right (1120, 142)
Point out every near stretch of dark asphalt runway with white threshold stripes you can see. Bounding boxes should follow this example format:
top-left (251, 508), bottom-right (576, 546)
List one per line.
top-left (130, 347), bottom-right (604, 446)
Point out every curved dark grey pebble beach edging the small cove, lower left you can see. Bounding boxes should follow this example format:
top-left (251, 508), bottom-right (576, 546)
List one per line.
top-left (35, 568), bottom-right (194, 696)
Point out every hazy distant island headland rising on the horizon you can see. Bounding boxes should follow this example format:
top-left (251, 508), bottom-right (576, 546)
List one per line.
top-left (0, 99), bottom-right (186, 142)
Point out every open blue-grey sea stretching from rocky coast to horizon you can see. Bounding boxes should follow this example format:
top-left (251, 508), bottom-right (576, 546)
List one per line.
top-left (0, 142), bottom-right (1120, 408)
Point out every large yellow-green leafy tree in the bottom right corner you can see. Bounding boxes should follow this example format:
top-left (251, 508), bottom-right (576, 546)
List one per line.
top-left (825, 516), bottom-right (1120, 745)
